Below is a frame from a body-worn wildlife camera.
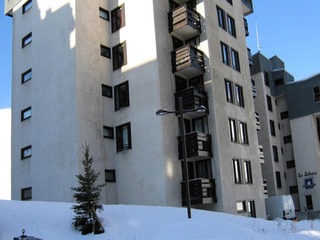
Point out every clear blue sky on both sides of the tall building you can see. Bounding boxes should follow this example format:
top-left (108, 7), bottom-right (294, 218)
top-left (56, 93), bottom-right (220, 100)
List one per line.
top-left (0, 0), bottom-right (320, 108)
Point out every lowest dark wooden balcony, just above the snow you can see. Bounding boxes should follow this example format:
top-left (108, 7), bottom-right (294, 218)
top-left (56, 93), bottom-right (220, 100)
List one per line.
top-left (181, 178), bottom-right (217, 206)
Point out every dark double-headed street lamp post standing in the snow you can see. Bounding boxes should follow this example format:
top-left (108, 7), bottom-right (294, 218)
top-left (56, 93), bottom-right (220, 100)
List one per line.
top-left (156, 97), bottom-right (206, 218)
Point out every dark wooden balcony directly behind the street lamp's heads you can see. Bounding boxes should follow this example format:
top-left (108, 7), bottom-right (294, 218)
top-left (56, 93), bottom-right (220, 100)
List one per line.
top-left (174, 87), bottom-right (208, 116)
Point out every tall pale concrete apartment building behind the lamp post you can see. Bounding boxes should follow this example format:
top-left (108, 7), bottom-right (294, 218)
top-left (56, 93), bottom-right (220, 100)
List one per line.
top-left (5, 0), bottom-right (265, 217)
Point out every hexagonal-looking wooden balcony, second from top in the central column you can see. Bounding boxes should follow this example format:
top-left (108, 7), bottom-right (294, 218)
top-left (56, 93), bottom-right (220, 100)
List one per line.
top-left (171, 45), bottom-right (204, 79)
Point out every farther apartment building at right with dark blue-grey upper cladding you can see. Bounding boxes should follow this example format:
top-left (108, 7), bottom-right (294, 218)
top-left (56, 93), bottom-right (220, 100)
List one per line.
top-left (251, 52), bottom-right (320, 211)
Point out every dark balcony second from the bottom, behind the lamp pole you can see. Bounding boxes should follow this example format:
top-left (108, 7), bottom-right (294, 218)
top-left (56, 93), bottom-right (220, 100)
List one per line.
top-left (178, 132), bottom-right (212, 161)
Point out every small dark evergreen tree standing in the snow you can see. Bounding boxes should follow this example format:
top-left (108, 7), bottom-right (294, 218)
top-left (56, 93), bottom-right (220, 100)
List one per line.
top-left (71, 144), bottom-right (105, 234)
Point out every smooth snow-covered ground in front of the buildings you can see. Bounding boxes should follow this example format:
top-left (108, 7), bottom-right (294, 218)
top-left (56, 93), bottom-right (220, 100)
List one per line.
top-left (0, 200), bottom-right (320, 240)
